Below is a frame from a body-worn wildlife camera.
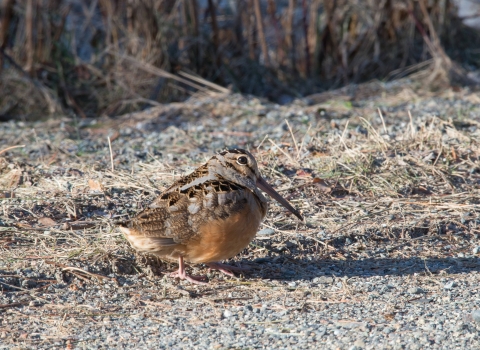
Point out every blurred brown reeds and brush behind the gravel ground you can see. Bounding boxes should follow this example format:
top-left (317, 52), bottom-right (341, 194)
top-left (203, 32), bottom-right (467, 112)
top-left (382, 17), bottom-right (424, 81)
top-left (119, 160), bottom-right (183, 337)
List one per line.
top-left (0, 0), bottom-right (480, 120)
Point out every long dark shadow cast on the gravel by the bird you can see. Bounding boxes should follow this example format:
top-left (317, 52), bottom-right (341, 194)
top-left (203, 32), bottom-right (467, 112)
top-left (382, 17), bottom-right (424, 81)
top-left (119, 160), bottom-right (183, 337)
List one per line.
top-left (234, 255), bottom-right (480, 281)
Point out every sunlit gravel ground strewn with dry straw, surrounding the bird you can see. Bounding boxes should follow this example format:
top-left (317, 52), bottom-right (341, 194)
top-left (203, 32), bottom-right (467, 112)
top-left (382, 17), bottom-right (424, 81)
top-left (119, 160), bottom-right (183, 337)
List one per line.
top-left (0, 80), bottom-right (480, 350)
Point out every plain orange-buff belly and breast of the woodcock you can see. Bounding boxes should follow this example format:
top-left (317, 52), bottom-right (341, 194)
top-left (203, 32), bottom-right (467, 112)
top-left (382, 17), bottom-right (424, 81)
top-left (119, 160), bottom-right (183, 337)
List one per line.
top-left (184, 201), bottom-right (265, 263)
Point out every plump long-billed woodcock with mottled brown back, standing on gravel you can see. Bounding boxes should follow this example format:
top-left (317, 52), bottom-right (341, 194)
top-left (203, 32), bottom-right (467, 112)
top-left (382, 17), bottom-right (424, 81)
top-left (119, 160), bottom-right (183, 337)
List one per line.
top-left (120, 149), bottom-right (303, 283)
